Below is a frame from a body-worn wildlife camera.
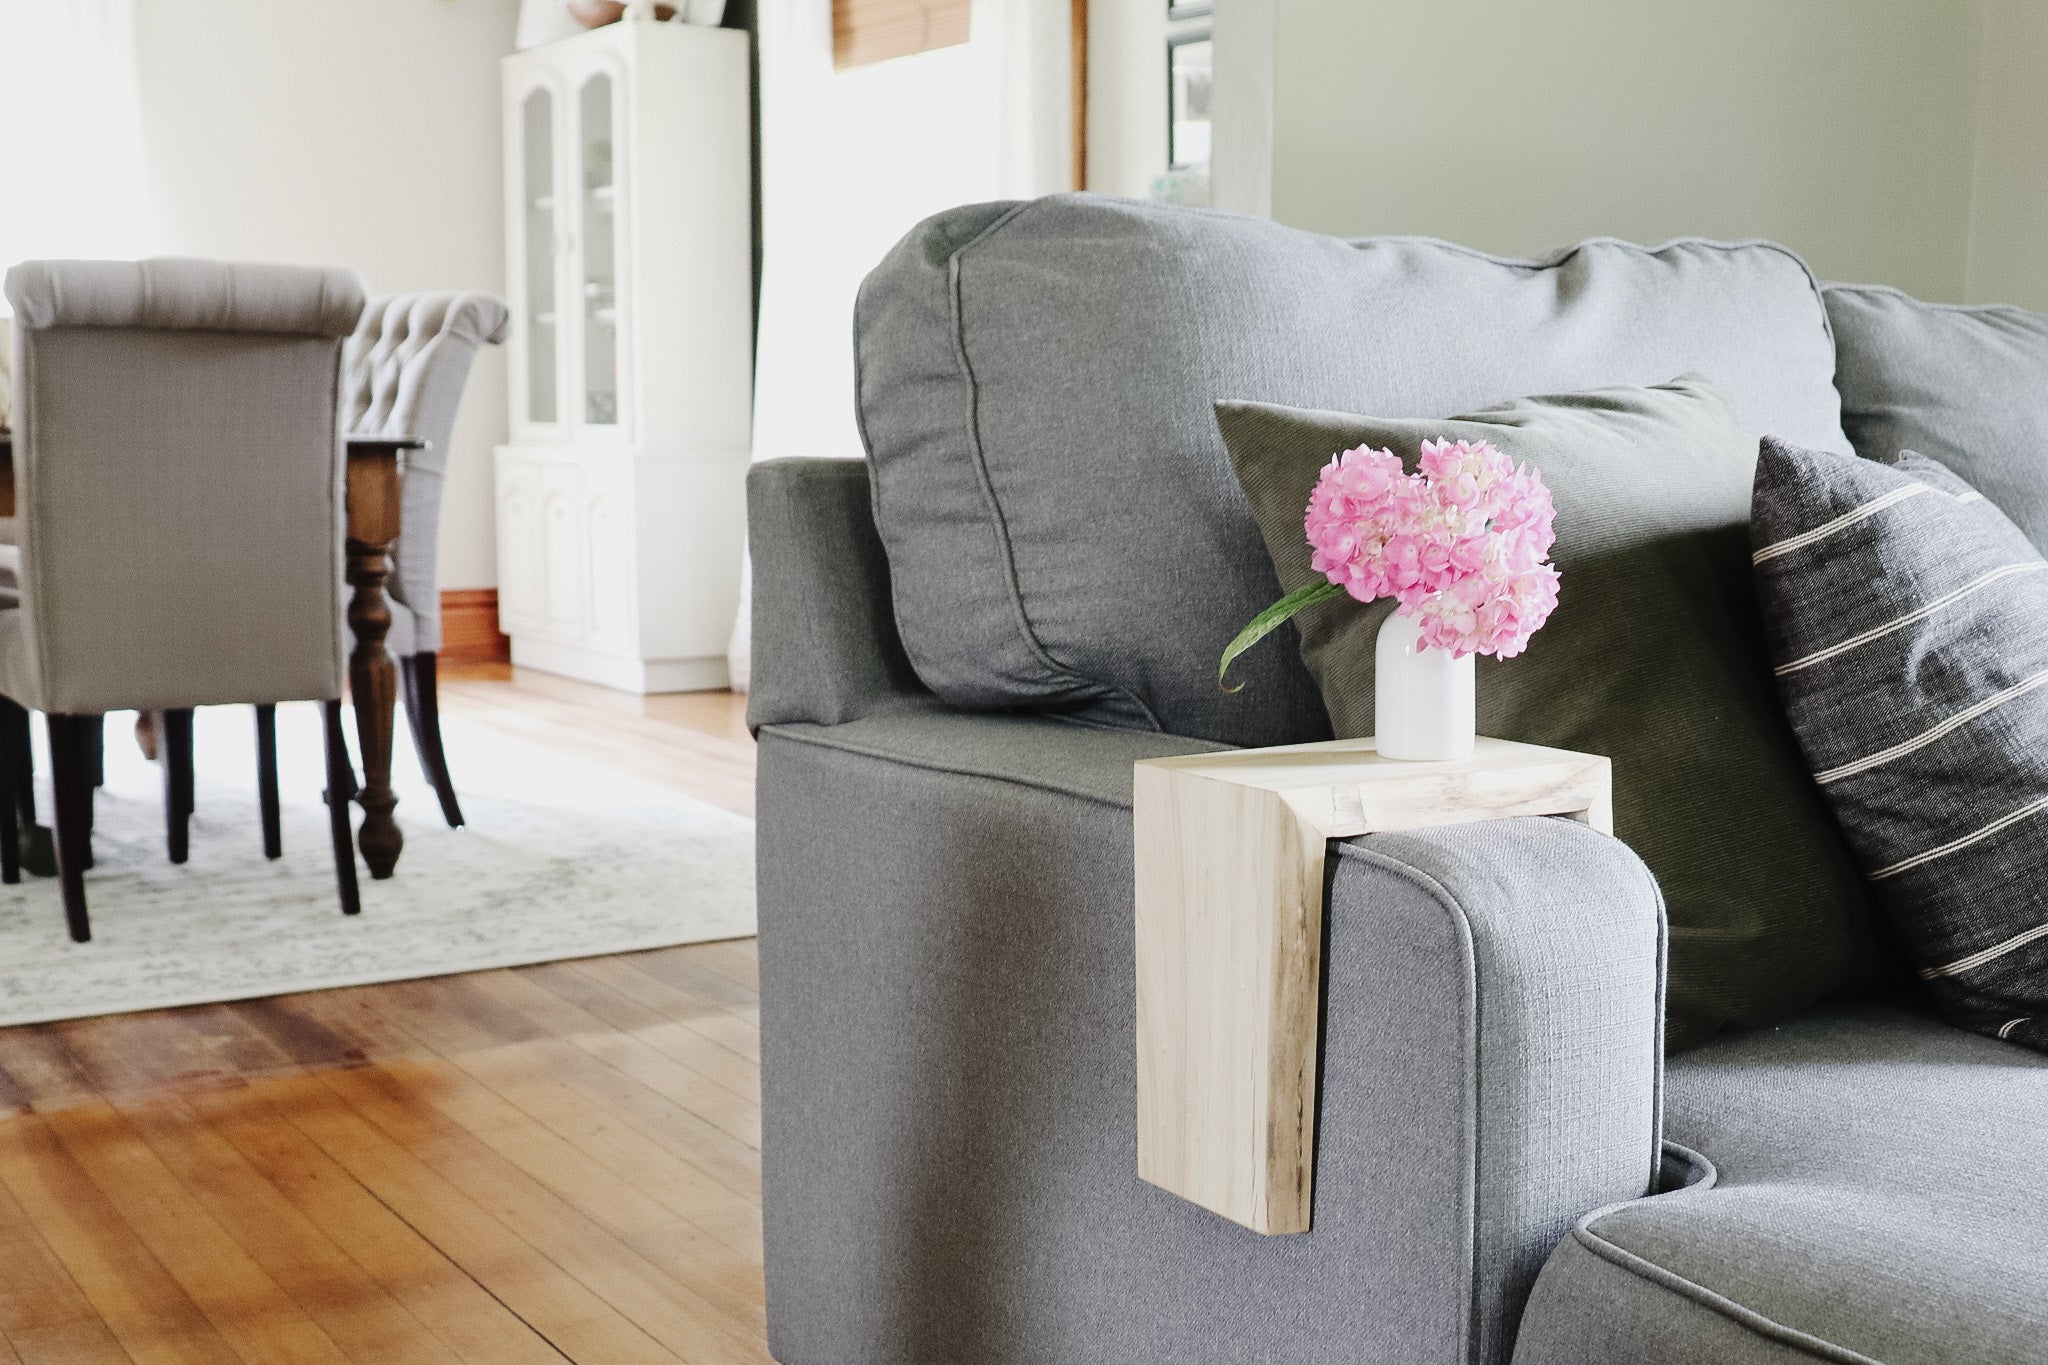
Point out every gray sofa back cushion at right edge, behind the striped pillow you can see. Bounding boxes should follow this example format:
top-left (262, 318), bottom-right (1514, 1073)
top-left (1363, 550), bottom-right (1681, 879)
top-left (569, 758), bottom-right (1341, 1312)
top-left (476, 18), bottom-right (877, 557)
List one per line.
top-left (1826, 284), bottom-right (2048, 553)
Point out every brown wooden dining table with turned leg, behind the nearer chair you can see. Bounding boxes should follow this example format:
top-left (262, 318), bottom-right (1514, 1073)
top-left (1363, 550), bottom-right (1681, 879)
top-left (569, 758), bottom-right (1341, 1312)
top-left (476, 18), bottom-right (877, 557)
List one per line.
top-left (0, 428), bottom-right (411, 880)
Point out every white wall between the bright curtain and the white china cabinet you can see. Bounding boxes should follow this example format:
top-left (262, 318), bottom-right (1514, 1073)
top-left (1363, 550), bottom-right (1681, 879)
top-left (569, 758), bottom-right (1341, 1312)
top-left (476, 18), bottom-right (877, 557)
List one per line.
top-left (135, 0), bottom-right (518, 587)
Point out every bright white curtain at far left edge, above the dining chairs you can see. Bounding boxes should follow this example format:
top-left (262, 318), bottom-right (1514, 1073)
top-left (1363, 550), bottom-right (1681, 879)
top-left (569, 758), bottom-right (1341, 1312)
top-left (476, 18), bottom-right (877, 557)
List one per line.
top-left (0, 0), bottom-right (152, 296)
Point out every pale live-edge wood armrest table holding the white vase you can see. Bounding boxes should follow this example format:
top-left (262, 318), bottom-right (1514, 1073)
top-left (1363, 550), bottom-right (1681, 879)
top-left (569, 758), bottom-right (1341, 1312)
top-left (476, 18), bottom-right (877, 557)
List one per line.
top-left (1133, 739), bottom-right (1614, 1234)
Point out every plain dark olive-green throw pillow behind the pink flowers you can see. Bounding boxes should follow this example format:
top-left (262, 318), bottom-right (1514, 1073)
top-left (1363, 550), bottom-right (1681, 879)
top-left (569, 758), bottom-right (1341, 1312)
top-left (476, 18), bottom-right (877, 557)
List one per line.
top-left (1217, 377), bottom-right (1884, 1050)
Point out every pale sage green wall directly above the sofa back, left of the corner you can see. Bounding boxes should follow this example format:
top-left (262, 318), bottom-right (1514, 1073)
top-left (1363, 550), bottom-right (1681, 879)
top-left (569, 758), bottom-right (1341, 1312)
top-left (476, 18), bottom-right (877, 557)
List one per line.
top-left (1272, 0), bottom-right (1974, 301)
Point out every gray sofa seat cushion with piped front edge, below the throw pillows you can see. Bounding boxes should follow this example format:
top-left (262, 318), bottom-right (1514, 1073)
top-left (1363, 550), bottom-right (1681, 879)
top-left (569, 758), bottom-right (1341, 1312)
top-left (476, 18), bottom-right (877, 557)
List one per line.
top-left (1516, 1005), bottom-right (2048, 1365)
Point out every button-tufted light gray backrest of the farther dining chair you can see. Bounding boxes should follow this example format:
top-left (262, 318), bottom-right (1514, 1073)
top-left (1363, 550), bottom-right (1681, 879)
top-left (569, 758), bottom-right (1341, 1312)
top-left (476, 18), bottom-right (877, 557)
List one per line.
top-left (342, 291), bottom-right (510, 651)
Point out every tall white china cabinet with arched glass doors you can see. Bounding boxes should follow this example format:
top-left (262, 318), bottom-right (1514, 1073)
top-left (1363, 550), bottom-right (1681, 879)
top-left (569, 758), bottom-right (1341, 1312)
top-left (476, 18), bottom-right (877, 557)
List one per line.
top-left (498, 18), bottom-right (754, 692)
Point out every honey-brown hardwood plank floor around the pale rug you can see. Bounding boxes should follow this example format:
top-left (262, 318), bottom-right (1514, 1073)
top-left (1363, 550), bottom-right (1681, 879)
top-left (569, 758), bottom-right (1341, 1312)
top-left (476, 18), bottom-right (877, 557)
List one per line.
top-left (0, 665), bottom-right (768, 1365)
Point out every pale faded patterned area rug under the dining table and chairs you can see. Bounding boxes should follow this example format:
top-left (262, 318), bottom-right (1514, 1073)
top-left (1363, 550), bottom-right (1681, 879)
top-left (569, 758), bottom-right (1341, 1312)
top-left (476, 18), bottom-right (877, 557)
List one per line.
top-left (0, 704), bottom-right (754, 1025)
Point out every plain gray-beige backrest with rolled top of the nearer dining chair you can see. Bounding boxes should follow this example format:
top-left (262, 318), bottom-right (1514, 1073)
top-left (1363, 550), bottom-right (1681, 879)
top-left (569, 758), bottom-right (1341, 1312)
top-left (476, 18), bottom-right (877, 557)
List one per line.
top-left (6, 260), bottom-right (362, 714)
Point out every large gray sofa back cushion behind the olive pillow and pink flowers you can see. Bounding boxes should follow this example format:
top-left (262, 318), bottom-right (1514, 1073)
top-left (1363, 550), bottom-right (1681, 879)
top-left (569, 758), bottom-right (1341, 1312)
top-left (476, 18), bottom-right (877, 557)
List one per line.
top-left (854, 194), bottom-right (1849, 745)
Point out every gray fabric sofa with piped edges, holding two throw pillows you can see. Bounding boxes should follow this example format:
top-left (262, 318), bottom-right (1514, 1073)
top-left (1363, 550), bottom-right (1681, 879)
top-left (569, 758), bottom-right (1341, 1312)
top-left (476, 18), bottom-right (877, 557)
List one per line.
top-left (750, 196), bottom-right (2048, 1365)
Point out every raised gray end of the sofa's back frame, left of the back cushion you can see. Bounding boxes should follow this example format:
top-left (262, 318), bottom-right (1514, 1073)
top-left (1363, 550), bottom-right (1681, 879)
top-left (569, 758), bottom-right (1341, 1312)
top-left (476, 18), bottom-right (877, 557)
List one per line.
top-left (748, 458), bottom-right (932, 731)
